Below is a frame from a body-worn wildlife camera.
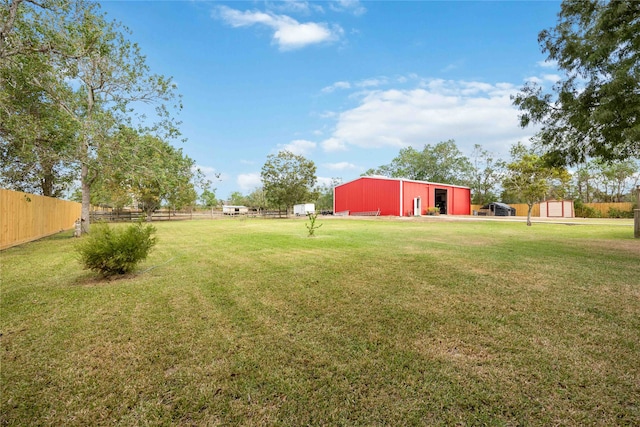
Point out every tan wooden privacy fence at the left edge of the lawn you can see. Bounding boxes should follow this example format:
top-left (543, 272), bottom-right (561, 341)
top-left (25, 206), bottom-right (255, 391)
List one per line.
top-left (0, 189), bottom-right (82, 250)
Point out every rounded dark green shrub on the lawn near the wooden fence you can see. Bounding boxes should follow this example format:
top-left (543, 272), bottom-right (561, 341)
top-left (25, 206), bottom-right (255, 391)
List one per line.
top-left (77, 222), bottom-right (157, 277)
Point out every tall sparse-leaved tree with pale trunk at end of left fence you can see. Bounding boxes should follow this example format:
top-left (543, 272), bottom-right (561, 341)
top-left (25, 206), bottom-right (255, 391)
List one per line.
top-left (0, 0), bottom-right (179, 232)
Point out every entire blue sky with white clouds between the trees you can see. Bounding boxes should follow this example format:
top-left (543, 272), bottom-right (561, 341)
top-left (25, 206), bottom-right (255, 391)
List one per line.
top-left (101, 0), bottom-right (560, 199)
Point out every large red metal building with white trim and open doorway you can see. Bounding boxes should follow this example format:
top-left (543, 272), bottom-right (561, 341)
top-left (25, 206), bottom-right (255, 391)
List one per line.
top-left (333, 176), bottom-right (471, 216)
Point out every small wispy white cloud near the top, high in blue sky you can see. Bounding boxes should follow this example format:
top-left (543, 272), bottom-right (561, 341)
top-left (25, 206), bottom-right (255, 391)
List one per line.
top-left (216, 6), bottom-right (344, 50)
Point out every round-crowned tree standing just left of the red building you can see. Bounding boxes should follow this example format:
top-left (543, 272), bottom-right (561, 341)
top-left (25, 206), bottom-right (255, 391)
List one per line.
top-left (261, 150), bottom-right (317, 216)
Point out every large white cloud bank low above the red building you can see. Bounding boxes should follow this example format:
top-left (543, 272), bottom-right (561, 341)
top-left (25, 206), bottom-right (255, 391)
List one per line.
top-left (322, 80), bottom-right (535, 153)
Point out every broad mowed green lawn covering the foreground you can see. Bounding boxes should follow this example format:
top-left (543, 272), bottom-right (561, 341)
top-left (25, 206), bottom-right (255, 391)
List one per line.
top-left (0, 218), bottom-right (640, 426)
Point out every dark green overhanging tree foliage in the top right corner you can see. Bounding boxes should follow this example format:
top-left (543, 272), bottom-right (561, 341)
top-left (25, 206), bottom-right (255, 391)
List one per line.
top-left (513, 0), bottom-right (640, 164)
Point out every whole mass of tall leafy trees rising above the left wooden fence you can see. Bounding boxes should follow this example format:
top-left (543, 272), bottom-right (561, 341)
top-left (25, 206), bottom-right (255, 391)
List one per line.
top-left (0, 0), bottom-right (202, 232)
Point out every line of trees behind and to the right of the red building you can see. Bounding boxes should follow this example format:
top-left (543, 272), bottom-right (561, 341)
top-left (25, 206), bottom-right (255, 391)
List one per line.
top-left (363, 140), bottom-right (640, 205)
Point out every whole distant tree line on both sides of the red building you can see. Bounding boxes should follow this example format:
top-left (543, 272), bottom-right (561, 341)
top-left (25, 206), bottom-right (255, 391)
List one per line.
top-left (228, 140), bottom-right (640, 224)
